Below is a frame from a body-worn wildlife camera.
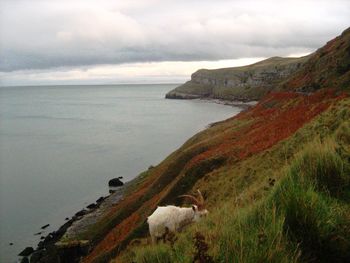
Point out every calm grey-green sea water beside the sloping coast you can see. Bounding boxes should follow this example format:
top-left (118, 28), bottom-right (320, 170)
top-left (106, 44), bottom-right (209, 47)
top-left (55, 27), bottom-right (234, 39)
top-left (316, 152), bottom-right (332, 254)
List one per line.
top-left (0, 84), bottom-right (239, 262)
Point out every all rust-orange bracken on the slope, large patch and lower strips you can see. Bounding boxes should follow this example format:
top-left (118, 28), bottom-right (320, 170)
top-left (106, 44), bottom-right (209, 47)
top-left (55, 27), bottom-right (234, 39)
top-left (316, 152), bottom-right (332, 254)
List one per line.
top-left (83, 90), bottom-right (345, 262)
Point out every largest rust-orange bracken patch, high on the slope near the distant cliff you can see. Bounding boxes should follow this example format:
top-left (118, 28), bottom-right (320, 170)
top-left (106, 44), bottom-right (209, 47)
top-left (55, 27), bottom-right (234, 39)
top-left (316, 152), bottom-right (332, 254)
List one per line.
top-left (187, 90), bottom-right (341, 168)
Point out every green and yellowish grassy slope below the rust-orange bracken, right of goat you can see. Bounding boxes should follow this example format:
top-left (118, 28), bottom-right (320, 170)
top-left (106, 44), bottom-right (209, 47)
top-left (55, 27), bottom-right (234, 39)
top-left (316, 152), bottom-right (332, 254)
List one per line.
top-left (124, 99), bottom-right (350, 262)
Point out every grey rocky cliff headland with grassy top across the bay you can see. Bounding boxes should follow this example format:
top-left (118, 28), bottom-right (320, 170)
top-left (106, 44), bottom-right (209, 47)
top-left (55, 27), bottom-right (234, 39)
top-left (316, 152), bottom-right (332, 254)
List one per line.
top-left (166, 56), bottom-right (309, 101)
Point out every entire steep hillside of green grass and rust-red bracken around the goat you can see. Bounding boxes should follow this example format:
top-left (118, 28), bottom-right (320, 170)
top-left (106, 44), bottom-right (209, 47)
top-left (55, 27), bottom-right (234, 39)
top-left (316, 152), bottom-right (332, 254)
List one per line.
top-left (63, 28), bottom-right (350, 262)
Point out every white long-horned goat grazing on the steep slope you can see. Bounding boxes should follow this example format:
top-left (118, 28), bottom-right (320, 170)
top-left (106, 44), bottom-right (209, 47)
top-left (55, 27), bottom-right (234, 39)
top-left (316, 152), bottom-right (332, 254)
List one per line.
top-left (147, 190), bottom-right (208, 243)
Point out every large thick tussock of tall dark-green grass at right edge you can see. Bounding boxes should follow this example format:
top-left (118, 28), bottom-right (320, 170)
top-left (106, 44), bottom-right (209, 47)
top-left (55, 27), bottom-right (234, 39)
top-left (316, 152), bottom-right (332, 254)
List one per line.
top-left (270, 140), bottom-right (350, 262)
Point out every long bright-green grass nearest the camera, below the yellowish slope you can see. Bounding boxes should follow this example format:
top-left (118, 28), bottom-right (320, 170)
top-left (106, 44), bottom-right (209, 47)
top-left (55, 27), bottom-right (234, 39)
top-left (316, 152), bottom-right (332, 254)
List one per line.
top-left (129, 138), bottom-right (350, 262)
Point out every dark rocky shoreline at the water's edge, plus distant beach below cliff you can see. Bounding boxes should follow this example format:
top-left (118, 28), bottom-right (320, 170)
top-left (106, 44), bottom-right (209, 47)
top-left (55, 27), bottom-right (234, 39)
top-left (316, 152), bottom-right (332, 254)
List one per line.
top-left (17, 98), bottom-right (241, 263)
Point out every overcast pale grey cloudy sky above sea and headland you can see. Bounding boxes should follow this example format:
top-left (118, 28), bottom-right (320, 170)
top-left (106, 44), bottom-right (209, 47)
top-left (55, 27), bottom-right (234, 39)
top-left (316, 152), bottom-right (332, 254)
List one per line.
top-left (0, 0), bottom-right (350, 85)
